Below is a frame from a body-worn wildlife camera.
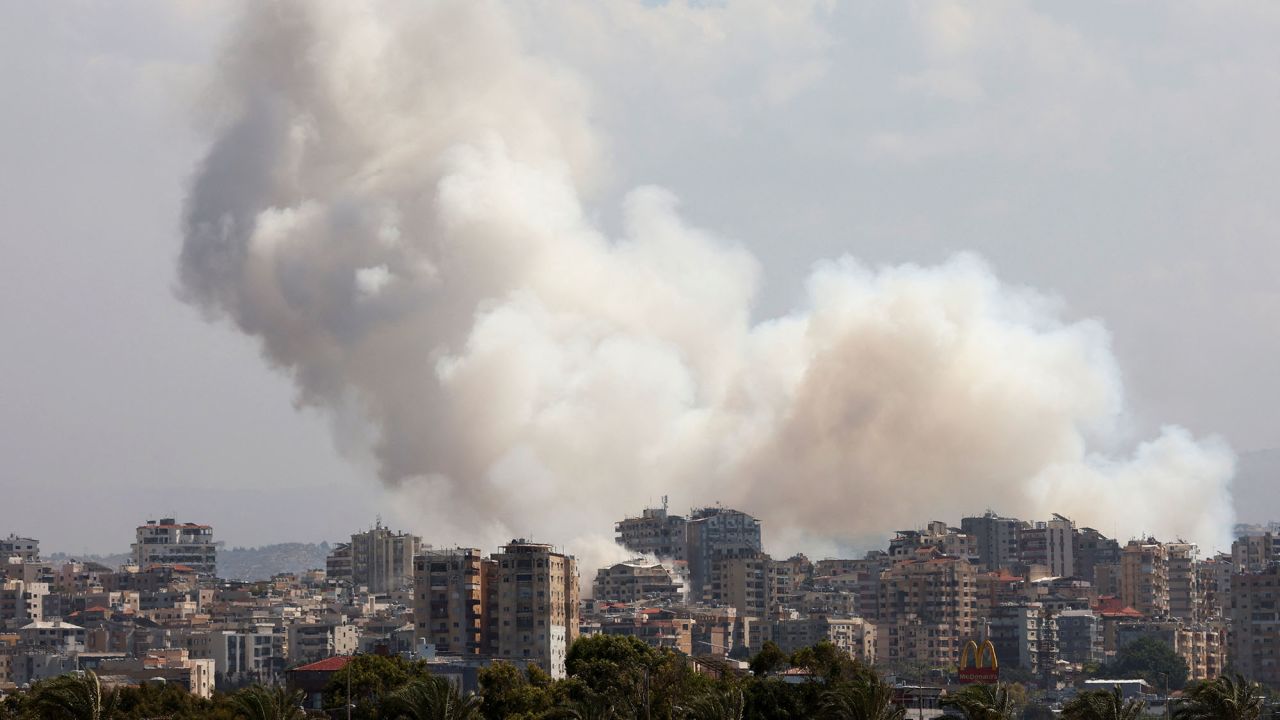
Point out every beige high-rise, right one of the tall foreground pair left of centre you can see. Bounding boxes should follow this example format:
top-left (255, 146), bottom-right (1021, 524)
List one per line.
top-left (493, 539), bottom-right (579, 678)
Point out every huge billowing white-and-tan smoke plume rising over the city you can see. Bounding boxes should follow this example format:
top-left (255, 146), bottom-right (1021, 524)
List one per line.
top-left (180, 1), bottom-right (1234, 552)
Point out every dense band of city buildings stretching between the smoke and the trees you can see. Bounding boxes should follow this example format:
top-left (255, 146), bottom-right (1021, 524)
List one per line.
top-left (0, 498), bottom-right (1280, 697)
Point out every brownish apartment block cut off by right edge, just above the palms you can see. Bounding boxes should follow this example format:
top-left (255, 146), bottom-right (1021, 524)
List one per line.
top-left (1230, 564), bottom-right (1280, 688)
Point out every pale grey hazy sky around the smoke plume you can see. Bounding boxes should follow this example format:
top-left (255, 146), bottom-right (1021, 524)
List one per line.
top-left (0, 3), bottom-right (1280, 552)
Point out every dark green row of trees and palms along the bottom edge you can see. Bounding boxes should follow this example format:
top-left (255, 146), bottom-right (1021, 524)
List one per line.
top-left (0, 635), bottom-right (1266, 720)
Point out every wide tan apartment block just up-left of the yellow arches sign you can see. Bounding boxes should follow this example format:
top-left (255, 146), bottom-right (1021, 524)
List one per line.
top-left (878, 548), bottom-right (977, 664)
